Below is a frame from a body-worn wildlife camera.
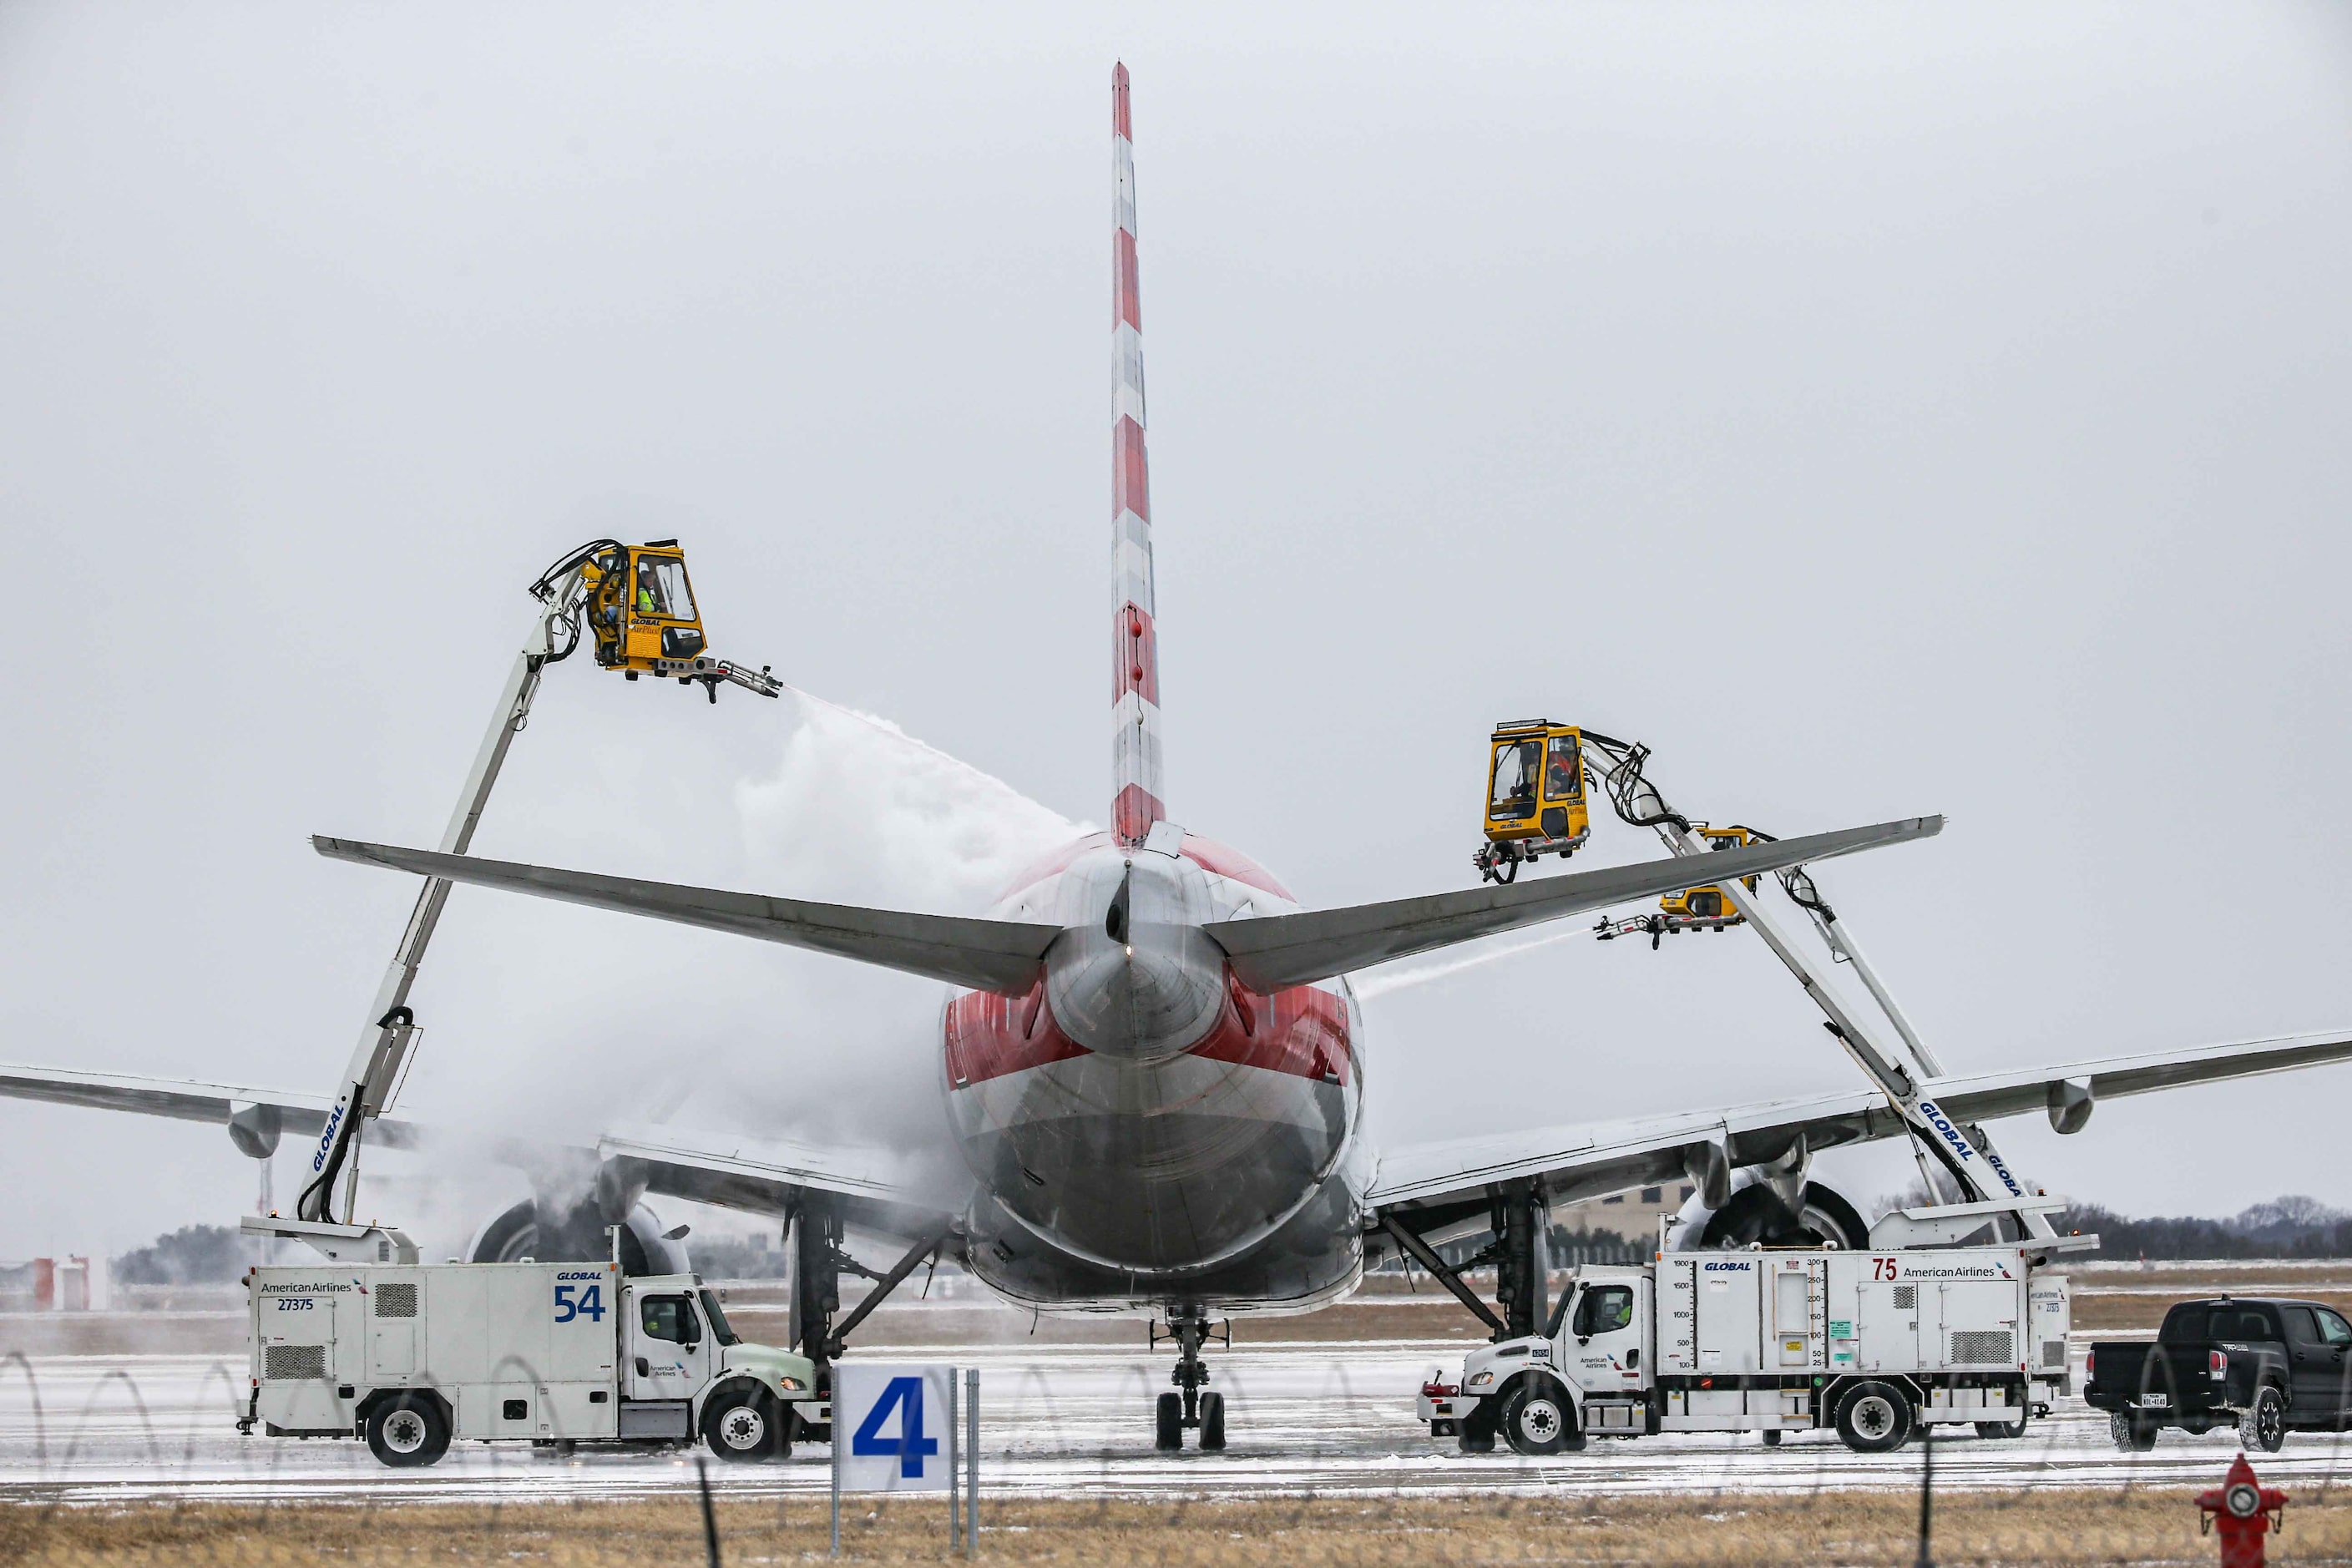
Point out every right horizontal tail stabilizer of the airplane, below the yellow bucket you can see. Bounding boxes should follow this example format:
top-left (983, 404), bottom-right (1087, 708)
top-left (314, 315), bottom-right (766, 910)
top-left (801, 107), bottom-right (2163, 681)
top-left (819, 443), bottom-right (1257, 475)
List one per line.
top-left (1206, 816), bottom-right (1943, 994)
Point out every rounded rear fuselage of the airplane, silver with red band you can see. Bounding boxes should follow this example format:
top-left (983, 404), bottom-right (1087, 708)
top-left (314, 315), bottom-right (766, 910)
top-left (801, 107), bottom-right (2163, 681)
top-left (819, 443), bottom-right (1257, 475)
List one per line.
top-left (941, 827), bottom-right (1367, 1312)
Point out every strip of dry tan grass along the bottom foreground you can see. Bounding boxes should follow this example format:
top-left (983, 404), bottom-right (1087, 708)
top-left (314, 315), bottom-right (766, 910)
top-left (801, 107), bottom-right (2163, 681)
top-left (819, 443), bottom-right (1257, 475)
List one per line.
top-left (0, 1488), bottom-right (2352, 1568)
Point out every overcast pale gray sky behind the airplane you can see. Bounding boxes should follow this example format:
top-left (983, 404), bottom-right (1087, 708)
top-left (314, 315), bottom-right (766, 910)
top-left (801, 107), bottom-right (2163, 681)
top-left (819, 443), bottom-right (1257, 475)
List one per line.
top-left (0, 5), bottom-right (2352, 1256)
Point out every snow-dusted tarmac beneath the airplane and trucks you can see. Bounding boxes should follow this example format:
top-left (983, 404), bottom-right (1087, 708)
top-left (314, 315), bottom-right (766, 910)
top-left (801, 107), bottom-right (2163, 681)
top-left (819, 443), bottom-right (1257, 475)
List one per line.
top-left (0, 1343), bottom-right (2352, 1505)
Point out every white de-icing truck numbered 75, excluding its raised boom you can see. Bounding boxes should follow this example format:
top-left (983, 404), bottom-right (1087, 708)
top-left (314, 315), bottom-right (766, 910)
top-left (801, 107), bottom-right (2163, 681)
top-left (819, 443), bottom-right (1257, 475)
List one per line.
top-left (1420, 1246), bottom-right (2072, 1455)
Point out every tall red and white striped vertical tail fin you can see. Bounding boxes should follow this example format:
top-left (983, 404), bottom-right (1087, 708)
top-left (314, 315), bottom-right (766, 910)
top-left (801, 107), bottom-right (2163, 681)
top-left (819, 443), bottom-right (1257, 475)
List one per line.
top-left (1110, 63), bottom-right (1166, 844)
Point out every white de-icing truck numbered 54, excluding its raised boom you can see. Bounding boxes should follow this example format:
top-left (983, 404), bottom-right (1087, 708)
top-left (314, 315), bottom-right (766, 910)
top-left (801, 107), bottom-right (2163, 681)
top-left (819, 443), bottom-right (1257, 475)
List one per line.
top-left (238, 1227), bottom-right (821, 1464)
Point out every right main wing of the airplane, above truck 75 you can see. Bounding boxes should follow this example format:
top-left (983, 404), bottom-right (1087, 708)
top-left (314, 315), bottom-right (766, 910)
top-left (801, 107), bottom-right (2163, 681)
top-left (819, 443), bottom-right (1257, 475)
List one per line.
top-left (1367, 1032), bottom-right (2352, 1239)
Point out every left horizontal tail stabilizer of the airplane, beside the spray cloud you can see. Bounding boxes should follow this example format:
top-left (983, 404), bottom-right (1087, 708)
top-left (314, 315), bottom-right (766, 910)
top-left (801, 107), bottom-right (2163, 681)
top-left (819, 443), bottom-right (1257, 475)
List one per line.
top-left (311, 837), bottom-right (1060, 994)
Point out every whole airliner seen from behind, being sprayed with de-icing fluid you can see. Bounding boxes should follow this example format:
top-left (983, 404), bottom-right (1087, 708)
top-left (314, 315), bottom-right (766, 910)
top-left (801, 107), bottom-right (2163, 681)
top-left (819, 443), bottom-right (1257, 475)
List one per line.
top-left (0, 66), bottom-right (2352, 1446)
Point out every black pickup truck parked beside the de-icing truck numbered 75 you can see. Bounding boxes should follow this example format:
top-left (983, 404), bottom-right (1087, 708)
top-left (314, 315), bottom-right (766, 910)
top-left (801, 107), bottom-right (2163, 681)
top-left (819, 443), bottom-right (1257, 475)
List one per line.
top-left (2081, 1295), bottom-right (2352, 1453)
